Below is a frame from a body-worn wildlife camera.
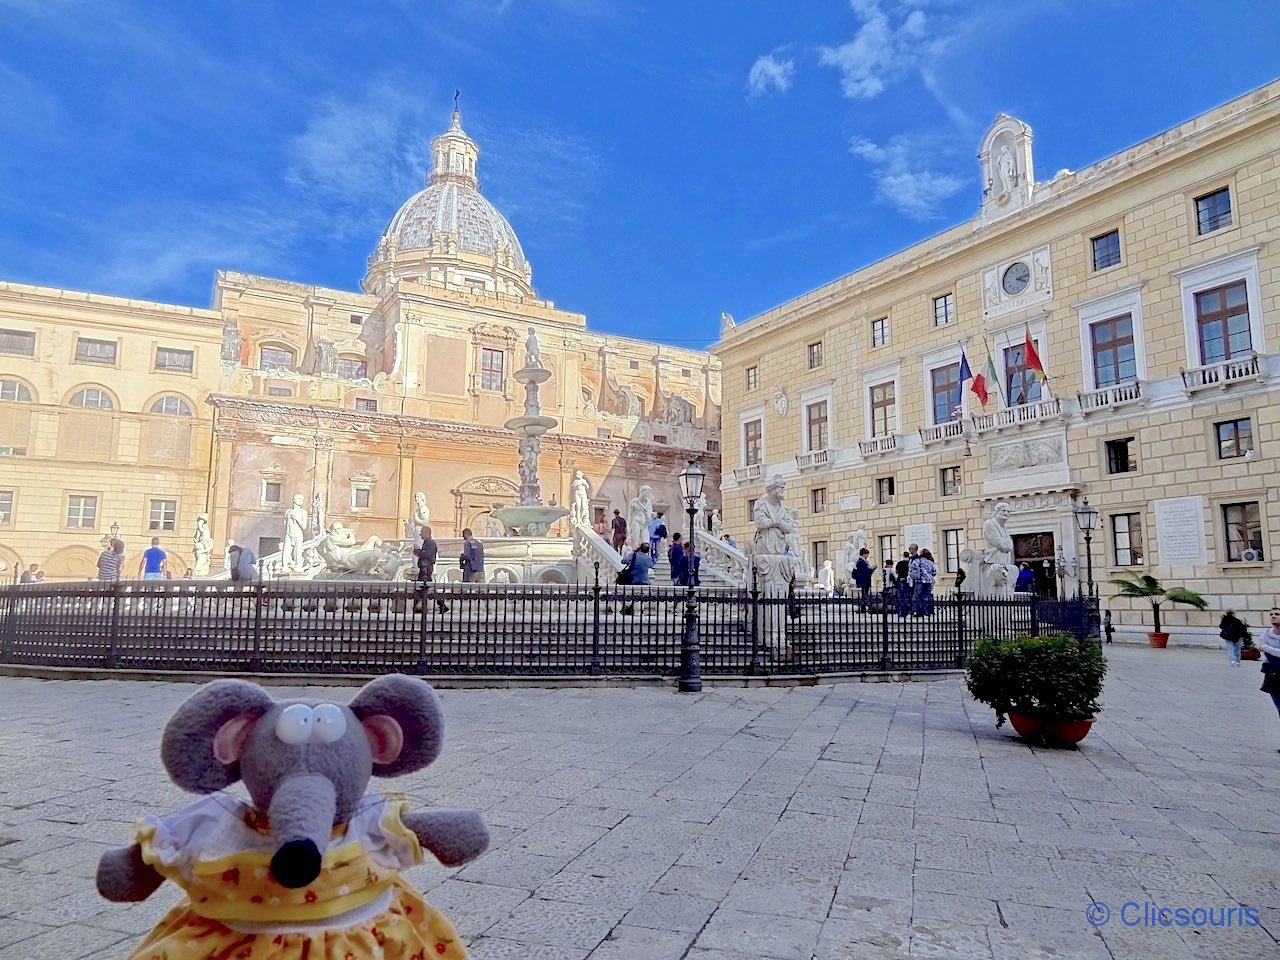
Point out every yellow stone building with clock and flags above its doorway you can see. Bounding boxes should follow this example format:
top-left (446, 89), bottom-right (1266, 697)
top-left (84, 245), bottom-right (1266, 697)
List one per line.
top-left (712, 83), bottom-right (1280, 640)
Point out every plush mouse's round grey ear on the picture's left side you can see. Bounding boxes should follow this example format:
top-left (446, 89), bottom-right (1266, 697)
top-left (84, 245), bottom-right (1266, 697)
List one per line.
top-left (160, 680), bottom-right (274, 794)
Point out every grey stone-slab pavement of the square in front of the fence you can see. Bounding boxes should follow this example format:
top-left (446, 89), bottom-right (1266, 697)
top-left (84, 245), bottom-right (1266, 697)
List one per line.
top-left (0, 645), bottom-right (1280, 960)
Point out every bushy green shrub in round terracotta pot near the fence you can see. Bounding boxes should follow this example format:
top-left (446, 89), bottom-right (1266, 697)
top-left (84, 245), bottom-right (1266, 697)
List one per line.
top-left (965, 634), bottom-right (1107, 746)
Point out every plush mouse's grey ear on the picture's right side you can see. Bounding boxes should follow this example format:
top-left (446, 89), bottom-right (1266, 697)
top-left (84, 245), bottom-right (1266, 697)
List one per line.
top-left (351, 673), bottom-right (444, 777)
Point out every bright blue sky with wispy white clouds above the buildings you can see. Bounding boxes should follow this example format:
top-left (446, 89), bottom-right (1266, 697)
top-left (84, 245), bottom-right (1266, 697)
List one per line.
top-left (0, 0), bottom-right (1280, 347)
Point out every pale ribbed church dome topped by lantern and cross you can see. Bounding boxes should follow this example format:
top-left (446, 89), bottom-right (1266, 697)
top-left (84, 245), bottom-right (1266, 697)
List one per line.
top-left (364, 109), bottom-right (536, 298)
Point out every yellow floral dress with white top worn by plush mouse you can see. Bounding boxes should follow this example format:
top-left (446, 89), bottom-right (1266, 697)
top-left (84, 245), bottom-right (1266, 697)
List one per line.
top-left (129, 795), bottom-right (467, 960)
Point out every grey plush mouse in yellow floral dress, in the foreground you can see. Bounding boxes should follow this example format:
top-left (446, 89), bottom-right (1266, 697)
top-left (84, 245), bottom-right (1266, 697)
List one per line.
top-left (97, 675), bottom-right (489, 960)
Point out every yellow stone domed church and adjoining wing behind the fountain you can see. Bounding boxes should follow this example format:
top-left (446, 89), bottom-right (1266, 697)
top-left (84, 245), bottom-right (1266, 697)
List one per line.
top-left (0, 111), bottom-right (721, 579)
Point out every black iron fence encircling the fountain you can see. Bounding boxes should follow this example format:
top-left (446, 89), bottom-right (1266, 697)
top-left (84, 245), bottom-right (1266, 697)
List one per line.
top-left (0, 581), bottom-right (1098, 676)
